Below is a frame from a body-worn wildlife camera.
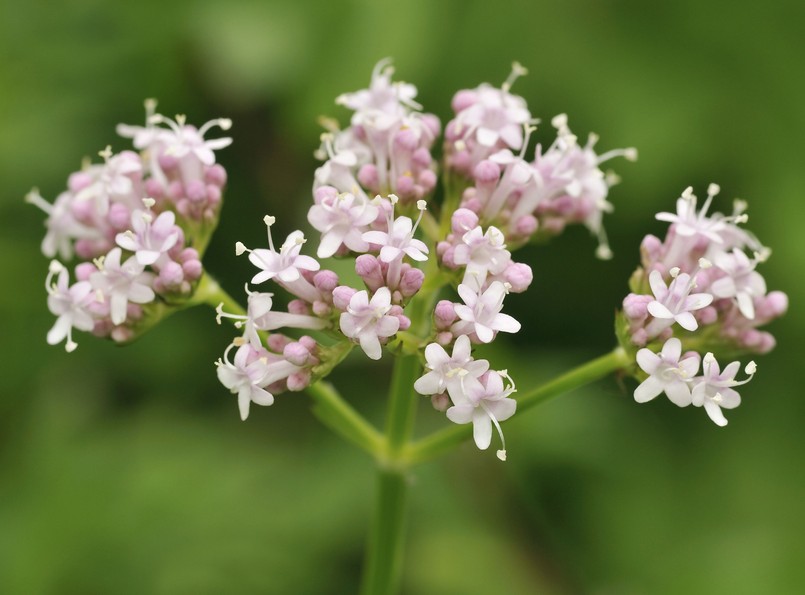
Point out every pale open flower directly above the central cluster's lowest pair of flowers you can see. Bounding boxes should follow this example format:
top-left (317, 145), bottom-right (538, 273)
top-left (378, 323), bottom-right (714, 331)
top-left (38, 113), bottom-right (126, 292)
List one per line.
top-left (455, 281), bottom-right (520, 343)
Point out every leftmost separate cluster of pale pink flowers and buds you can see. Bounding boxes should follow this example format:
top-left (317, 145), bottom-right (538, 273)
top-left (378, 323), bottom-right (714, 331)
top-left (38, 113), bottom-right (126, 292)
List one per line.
top-left (26, 100), bottom-right (232, 351)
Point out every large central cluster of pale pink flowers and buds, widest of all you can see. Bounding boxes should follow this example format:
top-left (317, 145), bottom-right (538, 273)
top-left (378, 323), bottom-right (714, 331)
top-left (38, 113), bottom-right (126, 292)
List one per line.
top-left (218, 60), bottom-right (635, 459)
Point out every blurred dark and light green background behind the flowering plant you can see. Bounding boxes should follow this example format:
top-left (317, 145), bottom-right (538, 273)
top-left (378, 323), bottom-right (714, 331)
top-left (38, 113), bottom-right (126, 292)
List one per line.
top-left (0, 0), bottom-right (805, 595)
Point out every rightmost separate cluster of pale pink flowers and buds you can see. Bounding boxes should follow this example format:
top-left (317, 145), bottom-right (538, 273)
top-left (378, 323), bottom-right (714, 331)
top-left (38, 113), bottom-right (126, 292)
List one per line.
top-left (617, 184), bottom-right (788, 426)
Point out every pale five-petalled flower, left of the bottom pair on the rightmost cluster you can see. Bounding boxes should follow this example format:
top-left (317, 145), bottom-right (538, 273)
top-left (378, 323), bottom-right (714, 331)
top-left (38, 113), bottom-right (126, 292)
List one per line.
top-left (634, 337), bottom-right (699, 407)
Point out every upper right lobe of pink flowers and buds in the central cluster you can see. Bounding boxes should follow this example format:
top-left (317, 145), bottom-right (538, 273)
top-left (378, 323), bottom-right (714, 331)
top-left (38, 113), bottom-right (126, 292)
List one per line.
top-left (445, 63), bottom-right (637, 258)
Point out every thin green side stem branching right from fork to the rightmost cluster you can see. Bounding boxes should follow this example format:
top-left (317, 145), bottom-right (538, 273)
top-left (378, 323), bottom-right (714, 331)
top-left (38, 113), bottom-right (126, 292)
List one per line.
top-left (403, 347), bottom-right (631, 465)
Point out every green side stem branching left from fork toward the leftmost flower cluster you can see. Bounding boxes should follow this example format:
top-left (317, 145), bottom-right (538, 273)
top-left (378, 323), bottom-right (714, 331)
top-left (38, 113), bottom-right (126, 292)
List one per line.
top-left (194, 273), bottom-right (385, 457)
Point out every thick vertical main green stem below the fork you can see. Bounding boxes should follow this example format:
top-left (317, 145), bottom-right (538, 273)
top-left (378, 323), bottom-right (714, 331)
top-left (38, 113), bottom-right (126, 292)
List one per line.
top-left (360, 468), bottom-right (408, 595)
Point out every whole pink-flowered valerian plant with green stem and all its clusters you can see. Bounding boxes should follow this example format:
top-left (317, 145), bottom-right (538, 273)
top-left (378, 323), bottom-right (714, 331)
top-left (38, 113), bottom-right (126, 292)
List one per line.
top-left (28, 60), bottom-right (787, 594)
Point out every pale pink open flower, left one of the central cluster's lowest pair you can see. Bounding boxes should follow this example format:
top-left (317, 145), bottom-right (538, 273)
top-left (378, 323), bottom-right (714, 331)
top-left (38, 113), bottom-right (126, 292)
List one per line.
top-left (414, 335), bottom-right (489, 395)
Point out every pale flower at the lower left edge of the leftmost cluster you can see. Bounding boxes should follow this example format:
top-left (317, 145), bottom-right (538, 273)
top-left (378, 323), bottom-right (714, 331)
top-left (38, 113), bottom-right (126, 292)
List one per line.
top-left (45, 260), bottom-right (95, 352)
